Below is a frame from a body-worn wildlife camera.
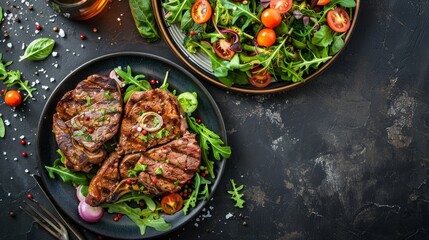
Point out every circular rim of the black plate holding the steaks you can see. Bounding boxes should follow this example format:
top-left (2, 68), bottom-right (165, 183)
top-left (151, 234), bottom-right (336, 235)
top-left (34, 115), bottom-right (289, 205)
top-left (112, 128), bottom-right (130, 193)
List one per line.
top-left (35, 51), bottom-right (228, 239)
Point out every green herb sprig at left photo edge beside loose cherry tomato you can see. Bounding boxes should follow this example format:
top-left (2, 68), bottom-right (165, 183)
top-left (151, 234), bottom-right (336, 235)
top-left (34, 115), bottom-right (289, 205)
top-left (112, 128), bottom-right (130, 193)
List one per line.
top-left (0, 54), bottom-right (36, 101)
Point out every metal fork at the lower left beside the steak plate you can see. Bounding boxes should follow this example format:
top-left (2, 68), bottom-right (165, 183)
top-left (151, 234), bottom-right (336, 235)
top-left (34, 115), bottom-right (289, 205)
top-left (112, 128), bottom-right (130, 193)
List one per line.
top-left (19, 199), bottom-right (69, 240)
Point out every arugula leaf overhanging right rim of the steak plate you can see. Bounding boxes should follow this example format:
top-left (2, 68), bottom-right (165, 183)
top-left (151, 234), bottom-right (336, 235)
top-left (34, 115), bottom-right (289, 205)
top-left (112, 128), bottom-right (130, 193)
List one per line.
top-left (186, 115), bottom-right (231, 178)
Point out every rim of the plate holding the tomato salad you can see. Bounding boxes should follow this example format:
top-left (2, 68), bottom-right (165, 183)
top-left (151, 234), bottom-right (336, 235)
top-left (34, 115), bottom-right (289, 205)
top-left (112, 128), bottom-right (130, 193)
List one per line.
top-left (151, 0), bottom-right (360, 94)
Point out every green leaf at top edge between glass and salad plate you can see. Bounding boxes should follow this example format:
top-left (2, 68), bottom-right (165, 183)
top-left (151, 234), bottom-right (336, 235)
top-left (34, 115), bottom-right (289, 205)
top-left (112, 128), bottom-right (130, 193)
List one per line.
top-left (129, 0), bottom-right (160, 42)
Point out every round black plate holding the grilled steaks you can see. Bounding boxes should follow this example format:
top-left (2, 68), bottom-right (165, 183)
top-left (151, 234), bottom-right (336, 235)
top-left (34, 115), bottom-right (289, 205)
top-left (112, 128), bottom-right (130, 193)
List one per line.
top-left (36, 52), bottom-right (227, 239)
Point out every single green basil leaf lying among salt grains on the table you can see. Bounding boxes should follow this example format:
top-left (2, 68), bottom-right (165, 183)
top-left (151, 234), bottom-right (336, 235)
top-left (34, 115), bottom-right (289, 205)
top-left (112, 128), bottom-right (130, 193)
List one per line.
top-left (19, 38), bottom-right (55, 62)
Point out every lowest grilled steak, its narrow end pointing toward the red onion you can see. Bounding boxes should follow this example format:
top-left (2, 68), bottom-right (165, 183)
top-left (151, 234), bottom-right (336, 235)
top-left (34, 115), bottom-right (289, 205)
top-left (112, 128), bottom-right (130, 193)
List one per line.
top-left (86, 132), bottom-right (201, 206)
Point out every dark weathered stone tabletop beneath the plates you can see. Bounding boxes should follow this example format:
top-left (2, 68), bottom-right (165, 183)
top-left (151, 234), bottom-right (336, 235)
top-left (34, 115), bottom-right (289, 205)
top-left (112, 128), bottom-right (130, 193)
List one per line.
top-left (0, 0), bottom-right (429, 240)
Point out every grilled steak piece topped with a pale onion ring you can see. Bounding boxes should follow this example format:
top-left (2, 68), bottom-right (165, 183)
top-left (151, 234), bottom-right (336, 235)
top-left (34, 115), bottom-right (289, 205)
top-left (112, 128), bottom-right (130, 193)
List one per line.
top-left (119, 89), bottom-right (188, 154)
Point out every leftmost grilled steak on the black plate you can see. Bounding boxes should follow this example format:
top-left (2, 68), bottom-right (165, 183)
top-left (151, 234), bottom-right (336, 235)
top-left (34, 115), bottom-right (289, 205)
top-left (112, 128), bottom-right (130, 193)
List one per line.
top-left (53, 75), bottom-right (122, 172)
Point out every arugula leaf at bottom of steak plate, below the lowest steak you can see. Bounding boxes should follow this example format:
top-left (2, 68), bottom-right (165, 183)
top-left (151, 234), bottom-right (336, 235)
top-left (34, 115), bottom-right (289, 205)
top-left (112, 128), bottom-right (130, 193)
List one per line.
top-left (103, 203), bottom-right (171, 235)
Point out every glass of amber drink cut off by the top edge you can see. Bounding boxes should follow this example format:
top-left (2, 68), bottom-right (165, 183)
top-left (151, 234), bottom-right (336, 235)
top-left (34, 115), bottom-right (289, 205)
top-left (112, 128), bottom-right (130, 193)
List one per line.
top-left (49, 0), bottom-right (109, 21)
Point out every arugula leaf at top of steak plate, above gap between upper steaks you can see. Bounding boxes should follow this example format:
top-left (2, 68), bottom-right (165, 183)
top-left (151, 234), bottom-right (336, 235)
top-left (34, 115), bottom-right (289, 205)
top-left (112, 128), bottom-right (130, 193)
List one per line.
top-left (115, 66), bottom-right (152, 102)
